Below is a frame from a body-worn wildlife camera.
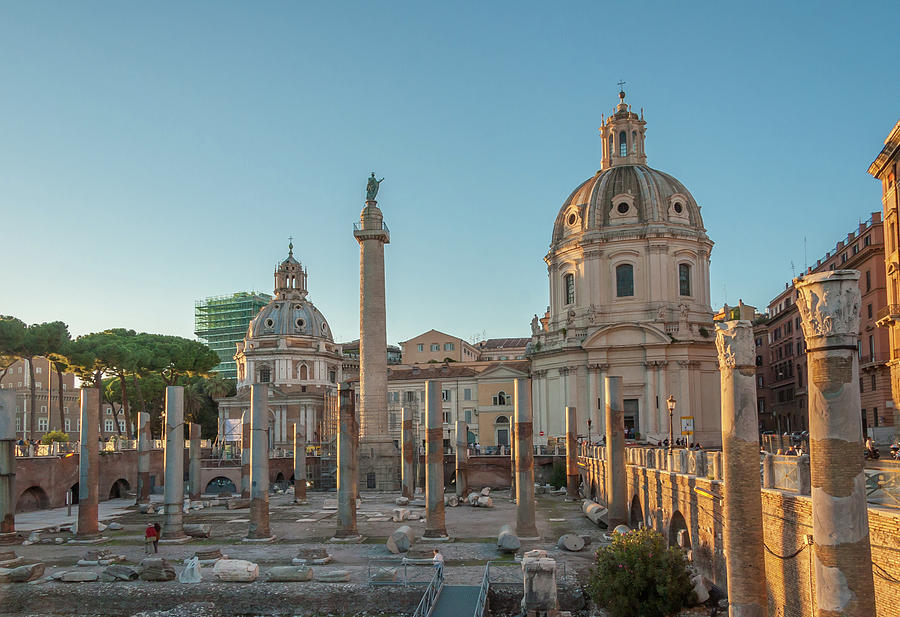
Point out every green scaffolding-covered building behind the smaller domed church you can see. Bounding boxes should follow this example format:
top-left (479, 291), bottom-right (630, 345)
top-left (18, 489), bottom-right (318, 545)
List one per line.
top-left (194, 291), bottom-right (272, 379)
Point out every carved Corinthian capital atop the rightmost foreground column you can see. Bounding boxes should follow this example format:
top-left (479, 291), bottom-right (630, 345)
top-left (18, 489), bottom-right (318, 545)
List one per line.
top-left (794, 270), bottom-right (860, 349)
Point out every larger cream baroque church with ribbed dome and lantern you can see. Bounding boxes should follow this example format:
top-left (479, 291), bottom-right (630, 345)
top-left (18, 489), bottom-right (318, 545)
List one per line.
top-left (528, 92), bottom-right (721, 445)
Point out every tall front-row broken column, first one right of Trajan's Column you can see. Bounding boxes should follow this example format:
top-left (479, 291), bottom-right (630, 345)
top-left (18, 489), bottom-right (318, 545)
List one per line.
top-left (423, 379), bottom-right (447, 538)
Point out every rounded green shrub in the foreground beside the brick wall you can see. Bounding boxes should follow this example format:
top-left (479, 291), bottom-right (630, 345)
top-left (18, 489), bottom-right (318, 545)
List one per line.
top-left (587, 529), bottom-right (696, 617)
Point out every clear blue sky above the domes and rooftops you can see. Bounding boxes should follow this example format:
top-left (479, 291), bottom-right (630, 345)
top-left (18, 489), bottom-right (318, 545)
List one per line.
top-left (0, 2), bottom-right (900, 342)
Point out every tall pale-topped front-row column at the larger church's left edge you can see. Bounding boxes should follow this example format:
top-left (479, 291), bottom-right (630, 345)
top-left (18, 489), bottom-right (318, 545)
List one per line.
top-left (513, 378), bottom-right (538, 538)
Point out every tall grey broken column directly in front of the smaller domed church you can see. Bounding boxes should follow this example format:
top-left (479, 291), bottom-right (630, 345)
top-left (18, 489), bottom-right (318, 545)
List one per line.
top-left (247, 383), bottom-right (273, 540)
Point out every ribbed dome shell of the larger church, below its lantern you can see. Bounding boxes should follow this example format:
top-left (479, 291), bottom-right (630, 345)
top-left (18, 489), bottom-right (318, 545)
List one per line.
top-left (553, 163), bottom-right (705, 244)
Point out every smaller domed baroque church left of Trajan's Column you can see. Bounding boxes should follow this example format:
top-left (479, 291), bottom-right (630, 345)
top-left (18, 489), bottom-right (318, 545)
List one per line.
top-left (219, 244), bottom-right (343, 449)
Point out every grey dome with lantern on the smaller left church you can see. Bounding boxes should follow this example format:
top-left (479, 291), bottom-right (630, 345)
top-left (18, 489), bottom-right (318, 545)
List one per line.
top-left (247, 243), bottom-right (334, 342)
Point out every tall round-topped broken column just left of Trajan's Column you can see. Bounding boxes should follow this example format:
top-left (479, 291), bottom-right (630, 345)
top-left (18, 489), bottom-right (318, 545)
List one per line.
top-left (334, 383), bottom-right (359, 539)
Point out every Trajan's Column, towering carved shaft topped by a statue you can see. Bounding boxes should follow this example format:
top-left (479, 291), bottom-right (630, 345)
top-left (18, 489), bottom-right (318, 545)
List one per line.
top-left (353, 173), bottom-right (400, 491)
